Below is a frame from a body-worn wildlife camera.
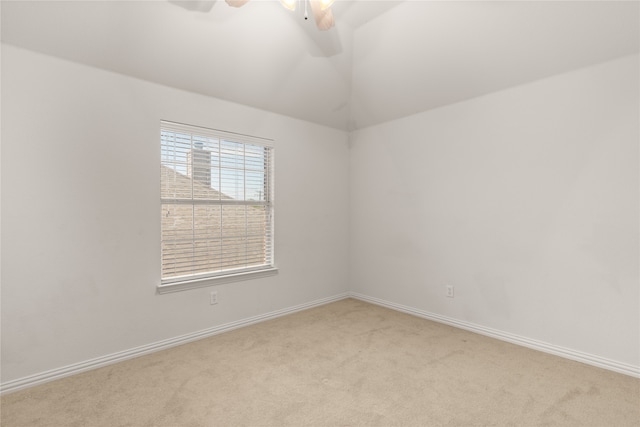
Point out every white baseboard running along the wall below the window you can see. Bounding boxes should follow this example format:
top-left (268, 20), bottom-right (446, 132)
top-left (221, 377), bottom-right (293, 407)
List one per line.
top-left (0, 292), bottom-right (349, 394)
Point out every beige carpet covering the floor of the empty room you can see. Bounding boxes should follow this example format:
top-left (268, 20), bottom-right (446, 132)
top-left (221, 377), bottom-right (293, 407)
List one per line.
top-left (1, 299), bottom-right (640, 427)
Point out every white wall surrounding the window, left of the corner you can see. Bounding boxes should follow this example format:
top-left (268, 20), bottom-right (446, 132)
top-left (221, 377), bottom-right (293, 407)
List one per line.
top-left (1, 45), bottom-right (348, 382)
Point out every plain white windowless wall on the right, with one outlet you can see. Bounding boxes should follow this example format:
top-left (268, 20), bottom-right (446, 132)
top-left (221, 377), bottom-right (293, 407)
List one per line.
top-left (350, 55), bottom-right (640, 369)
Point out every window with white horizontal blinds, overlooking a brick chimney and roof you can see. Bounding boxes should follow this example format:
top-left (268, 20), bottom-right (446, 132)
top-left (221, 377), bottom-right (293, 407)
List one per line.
top-left (159, 121), bottom-right (275, 291)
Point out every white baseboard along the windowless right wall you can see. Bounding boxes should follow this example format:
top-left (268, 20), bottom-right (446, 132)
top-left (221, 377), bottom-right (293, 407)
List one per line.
top-left (349, 292), bottom-right (640, 378)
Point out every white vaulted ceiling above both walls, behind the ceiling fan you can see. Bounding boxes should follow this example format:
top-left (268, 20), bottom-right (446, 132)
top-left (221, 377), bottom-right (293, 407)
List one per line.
top-left (0, 0), bottom-right (640, 130)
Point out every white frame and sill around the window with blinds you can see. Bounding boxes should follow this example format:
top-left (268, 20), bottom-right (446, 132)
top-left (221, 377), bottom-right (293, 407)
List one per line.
top-left (157, 120), bottom-right (278, 294)
